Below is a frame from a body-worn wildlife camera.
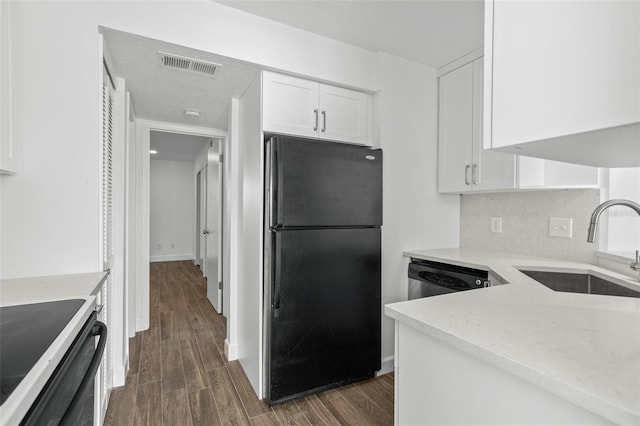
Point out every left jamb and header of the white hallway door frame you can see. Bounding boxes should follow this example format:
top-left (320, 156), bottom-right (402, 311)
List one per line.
top-left (135, 119), bottom-right (227, 331)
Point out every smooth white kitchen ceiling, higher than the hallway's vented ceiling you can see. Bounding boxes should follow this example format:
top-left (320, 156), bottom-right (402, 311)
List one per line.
top-left (216, 0), bottom-right (484, 68)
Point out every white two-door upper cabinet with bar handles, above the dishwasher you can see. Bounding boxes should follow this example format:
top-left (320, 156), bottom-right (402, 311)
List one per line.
top-left (438, 58), bottom-right (516, 193)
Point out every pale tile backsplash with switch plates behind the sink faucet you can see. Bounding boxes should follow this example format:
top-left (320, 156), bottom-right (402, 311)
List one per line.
top-left (460, 189), bottom-right (600, 263)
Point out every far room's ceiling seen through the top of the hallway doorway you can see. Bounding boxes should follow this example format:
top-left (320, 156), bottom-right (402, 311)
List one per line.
top-left (149, 131), bottom-right (211, 161)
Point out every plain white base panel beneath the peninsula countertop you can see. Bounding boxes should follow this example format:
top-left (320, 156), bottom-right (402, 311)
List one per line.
top-left (394, 322), bottom-right (612, 425)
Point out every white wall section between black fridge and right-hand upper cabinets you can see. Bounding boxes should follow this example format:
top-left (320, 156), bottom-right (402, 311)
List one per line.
top-left (374, 53), bottom-right (460, 371)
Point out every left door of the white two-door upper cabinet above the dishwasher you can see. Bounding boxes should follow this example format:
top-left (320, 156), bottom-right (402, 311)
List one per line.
top-left (438, 64), bottom-right (473, 192)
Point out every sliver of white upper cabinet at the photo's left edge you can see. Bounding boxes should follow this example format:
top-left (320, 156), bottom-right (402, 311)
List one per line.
top-left (0, 1), bottom-right (18, 174)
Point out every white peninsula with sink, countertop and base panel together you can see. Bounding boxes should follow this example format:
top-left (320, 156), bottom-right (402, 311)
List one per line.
top-left (385, 249), bottom-right (640, 425)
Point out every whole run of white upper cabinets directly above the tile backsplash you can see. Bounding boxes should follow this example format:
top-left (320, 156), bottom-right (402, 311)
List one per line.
top-left (438, 57), bottom-right (599, 194)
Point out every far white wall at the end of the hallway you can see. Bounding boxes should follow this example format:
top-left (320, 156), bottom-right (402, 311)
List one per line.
top-left (149, 160), bottom-right (196, 262)
